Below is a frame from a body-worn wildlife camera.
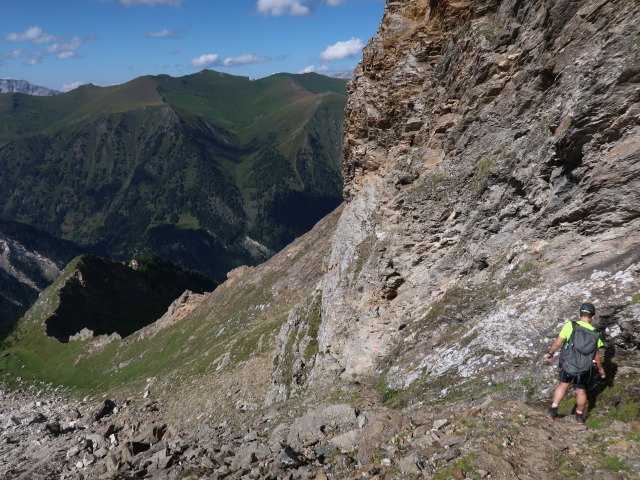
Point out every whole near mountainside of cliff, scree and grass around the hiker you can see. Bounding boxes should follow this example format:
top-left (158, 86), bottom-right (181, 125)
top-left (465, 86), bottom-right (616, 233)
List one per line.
top-left (0, 0), bottom-right (640, 480)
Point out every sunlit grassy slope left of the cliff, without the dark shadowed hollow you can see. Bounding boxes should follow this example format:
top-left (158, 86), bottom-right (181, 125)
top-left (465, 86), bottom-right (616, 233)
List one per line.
top-left (0, 206), bottom-right (338, 404)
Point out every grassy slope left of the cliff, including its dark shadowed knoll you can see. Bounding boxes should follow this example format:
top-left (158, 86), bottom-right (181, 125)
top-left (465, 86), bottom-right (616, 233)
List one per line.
top-left (0, 209), bottom-right (340, 398)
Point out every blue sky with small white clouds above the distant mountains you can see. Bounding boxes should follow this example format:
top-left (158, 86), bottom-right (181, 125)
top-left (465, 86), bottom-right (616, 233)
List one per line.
top-left (0, 0), bottom-right (384, 90)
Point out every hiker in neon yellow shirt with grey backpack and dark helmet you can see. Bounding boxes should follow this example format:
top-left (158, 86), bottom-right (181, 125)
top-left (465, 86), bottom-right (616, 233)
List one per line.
top-left (545, 303), bottom-right (606, 425)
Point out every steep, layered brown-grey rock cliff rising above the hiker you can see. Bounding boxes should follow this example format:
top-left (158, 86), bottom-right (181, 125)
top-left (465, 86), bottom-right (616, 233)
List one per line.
top-left (314, 0), bottom-right (640, 388)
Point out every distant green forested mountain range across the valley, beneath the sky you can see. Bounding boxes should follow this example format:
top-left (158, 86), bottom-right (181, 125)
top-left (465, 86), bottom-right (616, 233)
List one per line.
top-left (0, 70), bottom-right (345, 279)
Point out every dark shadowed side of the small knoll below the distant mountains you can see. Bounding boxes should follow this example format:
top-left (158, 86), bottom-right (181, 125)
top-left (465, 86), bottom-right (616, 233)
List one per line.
top-left (42, 255), bottom-right (215, 342)
